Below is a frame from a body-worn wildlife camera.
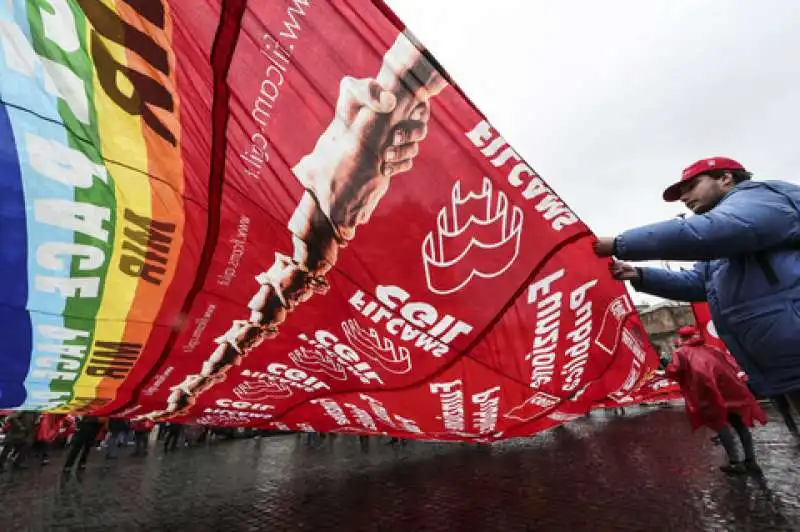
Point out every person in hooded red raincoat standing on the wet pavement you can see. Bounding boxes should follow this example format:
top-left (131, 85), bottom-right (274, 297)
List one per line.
top-left (666, 326), bottom-right (767, 474)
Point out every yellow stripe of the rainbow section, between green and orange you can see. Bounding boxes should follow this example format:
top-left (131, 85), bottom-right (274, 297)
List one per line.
top-left (58, 4), bottom-right (151, 412)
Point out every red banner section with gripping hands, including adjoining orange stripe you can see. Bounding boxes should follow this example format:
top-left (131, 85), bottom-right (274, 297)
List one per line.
top-left (0, 0), bottom-right (660, 440)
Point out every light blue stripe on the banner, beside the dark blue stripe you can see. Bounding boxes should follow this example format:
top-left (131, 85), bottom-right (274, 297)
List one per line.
top-left (0, 6), bottom-right (82, 410)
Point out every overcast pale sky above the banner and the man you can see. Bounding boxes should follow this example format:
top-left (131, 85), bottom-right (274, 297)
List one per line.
top-left (387, 0), bottom-right (800, 301)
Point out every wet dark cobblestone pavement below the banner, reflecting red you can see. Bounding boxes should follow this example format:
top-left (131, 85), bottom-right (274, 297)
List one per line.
top-left (0, 407), bottom-right (800, 532)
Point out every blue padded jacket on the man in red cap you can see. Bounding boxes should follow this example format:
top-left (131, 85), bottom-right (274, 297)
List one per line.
top-left (615, 181), bottom-right (800, 396)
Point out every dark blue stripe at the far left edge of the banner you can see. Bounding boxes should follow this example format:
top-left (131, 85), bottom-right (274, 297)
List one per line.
top-left (0, 105), bottom-right (32, 408)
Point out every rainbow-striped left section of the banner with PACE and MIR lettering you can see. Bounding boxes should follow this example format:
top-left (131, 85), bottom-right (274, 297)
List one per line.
top-left (0, 0), bottom-right (184, 412)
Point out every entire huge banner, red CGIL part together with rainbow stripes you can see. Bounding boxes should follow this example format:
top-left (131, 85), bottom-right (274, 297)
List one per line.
top-left (0, 0), bottom-right (658, 440)
